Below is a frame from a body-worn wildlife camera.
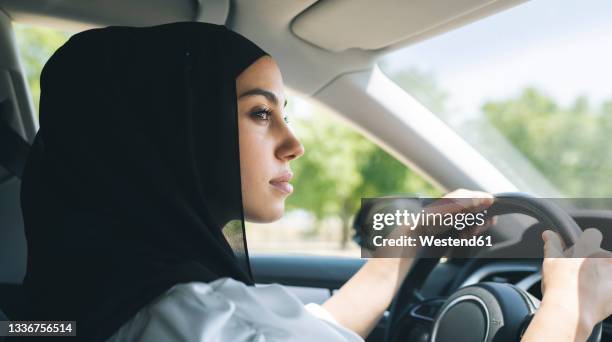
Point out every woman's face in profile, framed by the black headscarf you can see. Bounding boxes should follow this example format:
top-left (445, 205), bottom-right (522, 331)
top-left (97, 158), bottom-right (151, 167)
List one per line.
top-left (236, 56), bottom-right (304, 222)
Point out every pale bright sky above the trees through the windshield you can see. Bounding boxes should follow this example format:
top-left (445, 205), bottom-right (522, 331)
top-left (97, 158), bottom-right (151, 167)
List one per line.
top-left (384, 0), bottom-right (612, 116)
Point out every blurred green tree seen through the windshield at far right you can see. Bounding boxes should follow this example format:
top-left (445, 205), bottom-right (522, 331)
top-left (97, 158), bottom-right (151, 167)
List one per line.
top-left (482, 88), bottom-right (612, 197)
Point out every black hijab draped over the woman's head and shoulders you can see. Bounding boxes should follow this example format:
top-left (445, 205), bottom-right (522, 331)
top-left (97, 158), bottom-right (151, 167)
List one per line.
top-left (21, 22), bottom-right (267, 341)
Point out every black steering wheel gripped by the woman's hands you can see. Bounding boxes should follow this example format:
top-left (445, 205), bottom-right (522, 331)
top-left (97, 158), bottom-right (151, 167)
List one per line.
top-left (385, 193), bottom-right (602, 342)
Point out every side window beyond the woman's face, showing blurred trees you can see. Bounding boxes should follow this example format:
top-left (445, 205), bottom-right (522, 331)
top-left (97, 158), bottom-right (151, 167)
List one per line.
top-left (246, 93), bottom-right (442, 257)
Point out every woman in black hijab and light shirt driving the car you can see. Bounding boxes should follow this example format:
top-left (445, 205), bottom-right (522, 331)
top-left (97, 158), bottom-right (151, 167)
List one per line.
top-left (16, 23), bottom-right (611, 342)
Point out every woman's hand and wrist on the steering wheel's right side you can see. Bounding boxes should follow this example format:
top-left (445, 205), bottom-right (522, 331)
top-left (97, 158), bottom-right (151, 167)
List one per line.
top-left (523, 228), bottom-right (612, 341)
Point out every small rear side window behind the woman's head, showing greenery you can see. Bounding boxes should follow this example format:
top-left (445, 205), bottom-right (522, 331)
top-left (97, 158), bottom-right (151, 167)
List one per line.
top-left (13, 23), bottom-right (71, 118)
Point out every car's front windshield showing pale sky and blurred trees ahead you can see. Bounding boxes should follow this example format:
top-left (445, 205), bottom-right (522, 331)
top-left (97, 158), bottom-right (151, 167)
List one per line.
top-left (379, 0), bottom-right (612, 197)
